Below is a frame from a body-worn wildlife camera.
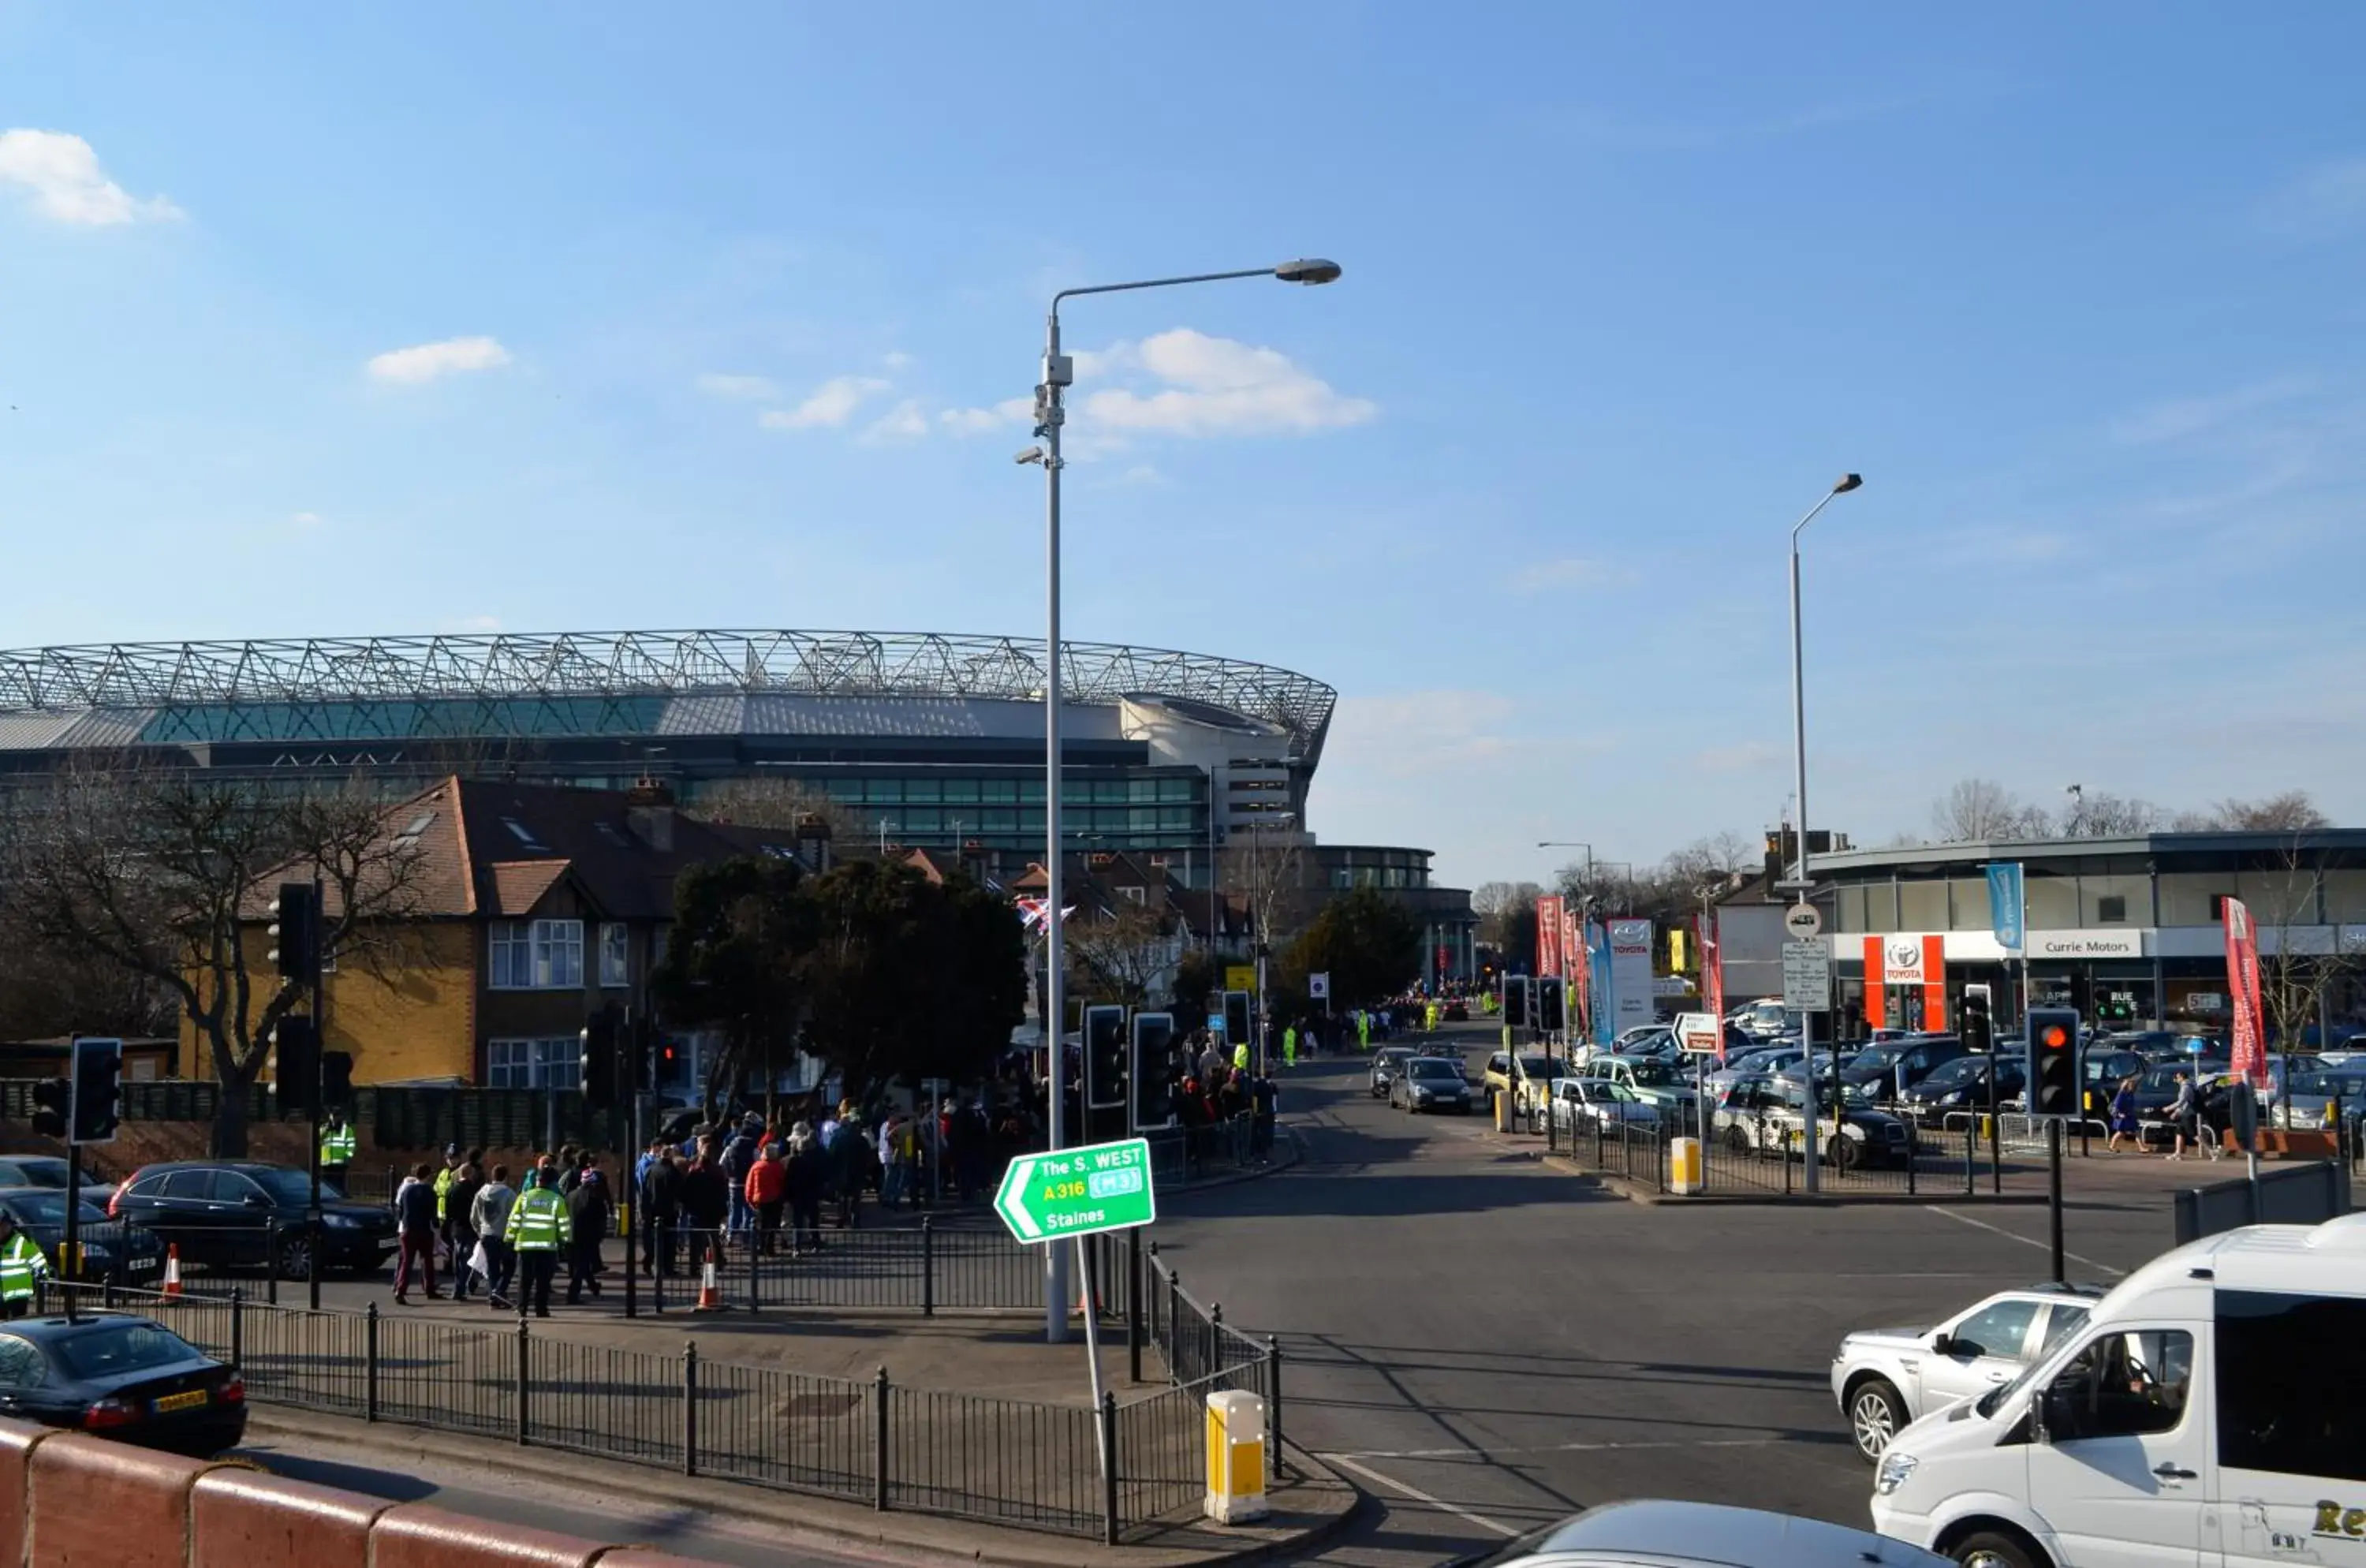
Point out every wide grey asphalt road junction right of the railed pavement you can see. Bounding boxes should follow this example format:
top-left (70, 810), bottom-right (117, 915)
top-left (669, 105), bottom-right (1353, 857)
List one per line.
top-left (1157, 1029), bottom-right (2170, 1568)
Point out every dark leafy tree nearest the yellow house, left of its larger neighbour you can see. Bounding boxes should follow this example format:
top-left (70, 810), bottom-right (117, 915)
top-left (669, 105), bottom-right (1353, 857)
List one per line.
top-left (648, 856), bottom-right (819, 1114)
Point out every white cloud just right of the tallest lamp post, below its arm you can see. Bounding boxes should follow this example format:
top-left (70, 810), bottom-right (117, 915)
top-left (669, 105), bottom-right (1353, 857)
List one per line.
top-left (1077, 327), bottom-right (1379, 435)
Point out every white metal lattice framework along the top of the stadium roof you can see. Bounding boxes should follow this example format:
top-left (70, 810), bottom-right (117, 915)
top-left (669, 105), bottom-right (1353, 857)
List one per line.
top-left (0, 632), bottom-right (1339, 767)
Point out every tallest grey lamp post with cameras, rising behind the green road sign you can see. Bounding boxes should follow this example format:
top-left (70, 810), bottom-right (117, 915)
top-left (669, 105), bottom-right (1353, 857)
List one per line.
top-left (1017, 258), bottom-right (1339, 1343)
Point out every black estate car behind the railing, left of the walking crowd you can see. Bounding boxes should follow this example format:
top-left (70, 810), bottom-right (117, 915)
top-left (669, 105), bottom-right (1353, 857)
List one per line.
top-left (106, 1159), bottom-right (395, 1279)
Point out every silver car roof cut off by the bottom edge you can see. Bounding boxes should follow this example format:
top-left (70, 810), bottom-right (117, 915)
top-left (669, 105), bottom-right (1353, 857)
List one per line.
top-left (1448, 1497), bottom-right (1954, 1568)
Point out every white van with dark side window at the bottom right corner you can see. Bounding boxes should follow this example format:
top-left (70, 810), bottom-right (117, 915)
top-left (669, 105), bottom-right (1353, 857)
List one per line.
top-left (1874, 1213), bottom-right (2366, 1568)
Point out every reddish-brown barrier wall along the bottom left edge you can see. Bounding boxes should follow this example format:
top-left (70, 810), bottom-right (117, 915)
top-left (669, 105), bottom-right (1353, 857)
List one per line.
top-left (0, 1419), bottom-right (729, 1568)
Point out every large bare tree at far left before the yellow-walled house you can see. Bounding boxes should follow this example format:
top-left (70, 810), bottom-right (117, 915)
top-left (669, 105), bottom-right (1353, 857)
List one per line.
top-left (0, 769), bottom-right (421, 1156)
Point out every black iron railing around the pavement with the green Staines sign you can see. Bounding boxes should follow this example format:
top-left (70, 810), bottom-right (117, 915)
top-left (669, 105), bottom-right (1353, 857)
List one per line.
top-left (43, 1232), bottom-right (1280, 1544)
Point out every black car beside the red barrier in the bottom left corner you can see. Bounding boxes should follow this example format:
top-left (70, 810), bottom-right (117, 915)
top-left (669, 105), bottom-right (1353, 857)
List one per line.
top-left (0, 1312), bottom-right (246, 1457)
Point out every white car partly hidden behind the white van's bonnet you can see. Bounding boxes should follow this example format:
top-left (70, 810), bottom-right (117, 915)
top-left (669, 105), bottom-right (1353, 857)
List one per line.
top-left (1831, 1284), bottom-right (2103, 1464)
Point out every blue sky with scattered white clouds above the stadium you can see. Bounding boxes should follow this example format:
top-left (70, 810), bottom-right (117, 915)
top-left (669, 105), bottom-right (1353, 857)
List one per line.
top-left (0, 0), bottom-right (2366, 887)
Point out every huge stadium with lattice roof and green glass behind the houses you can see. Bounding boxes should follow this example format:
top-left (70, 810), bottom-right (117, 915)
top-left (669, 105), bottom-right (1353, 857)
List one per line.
top-left (0, 632), bottom-right (1469, 969)
